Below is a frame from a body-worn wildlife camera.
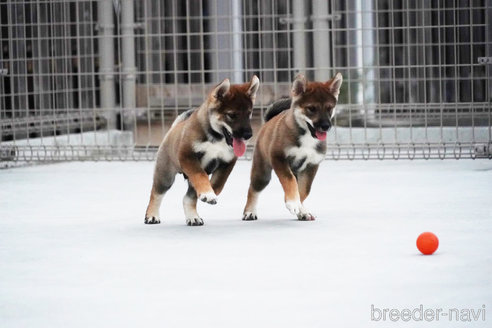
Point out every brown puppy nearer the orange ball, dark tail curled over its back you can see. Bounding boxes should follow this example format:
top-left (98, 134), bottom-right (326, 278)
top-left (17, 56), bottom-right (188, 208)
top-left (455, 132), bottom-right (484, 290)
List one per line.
top-left (243, 73), bottom-right (342, 220)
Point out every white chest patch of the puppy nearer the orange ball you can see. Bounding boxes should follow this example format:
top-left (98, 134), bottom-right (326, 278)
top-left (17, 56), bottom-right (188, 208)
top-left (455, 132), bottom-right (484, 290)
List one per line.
top-left (285, 133), bottom-right (326, 172)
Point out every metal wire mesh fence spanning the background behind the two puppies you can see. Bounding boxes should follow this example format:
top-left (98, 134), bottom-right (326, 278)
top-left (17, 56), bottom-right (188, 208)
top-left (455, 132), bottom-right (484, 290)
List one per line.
top-left (0, 0), bottom-right (492, 165)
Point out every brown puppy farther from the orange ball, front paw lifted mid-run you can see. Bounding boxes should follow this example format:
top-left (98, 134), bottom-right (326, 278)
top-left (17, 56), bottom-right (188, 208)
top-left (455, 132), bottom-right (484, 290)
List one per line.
top-left (145, 76), bottom-right (260, 226)
